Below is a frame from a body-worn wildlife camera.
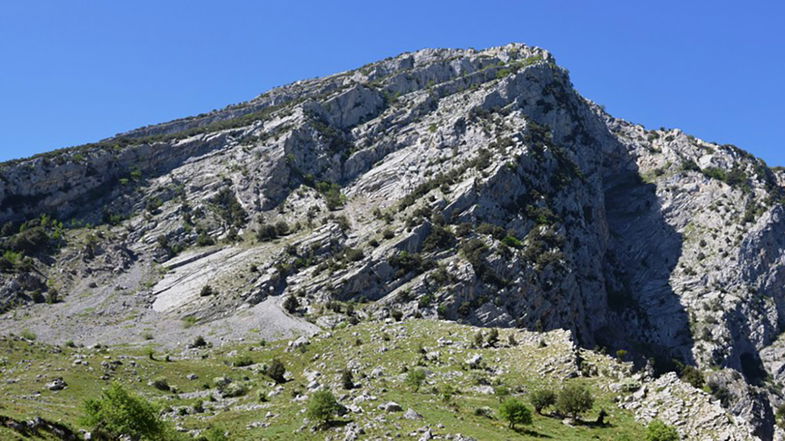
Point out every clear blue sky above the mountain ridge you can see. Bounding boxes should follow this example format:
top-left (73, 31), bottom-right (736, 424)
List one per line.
top-left (0, 0), bottom-right (785, 165)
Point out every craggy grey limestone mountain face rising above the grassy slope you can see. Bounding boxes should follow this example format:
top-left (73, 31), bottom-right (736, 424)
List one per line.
top-left (0, 44), bottom-right (785, 439)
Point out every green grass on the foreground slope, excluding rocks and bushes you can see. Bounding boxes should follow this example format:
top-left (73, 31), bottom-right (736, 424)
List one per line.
top-left (0, 320), bottom-right (642, 441)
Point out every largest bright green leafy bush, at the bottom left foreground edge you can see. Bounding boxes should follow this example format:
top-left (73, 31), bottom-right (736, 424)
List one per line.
top-left (81, 383), bottom-right (174, 441)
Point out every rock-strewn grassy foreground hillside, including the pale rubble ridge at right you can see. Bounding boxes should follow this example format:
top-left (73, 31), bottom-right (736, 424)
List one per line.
top-left (0, 319), bottom-right (752, 441)
